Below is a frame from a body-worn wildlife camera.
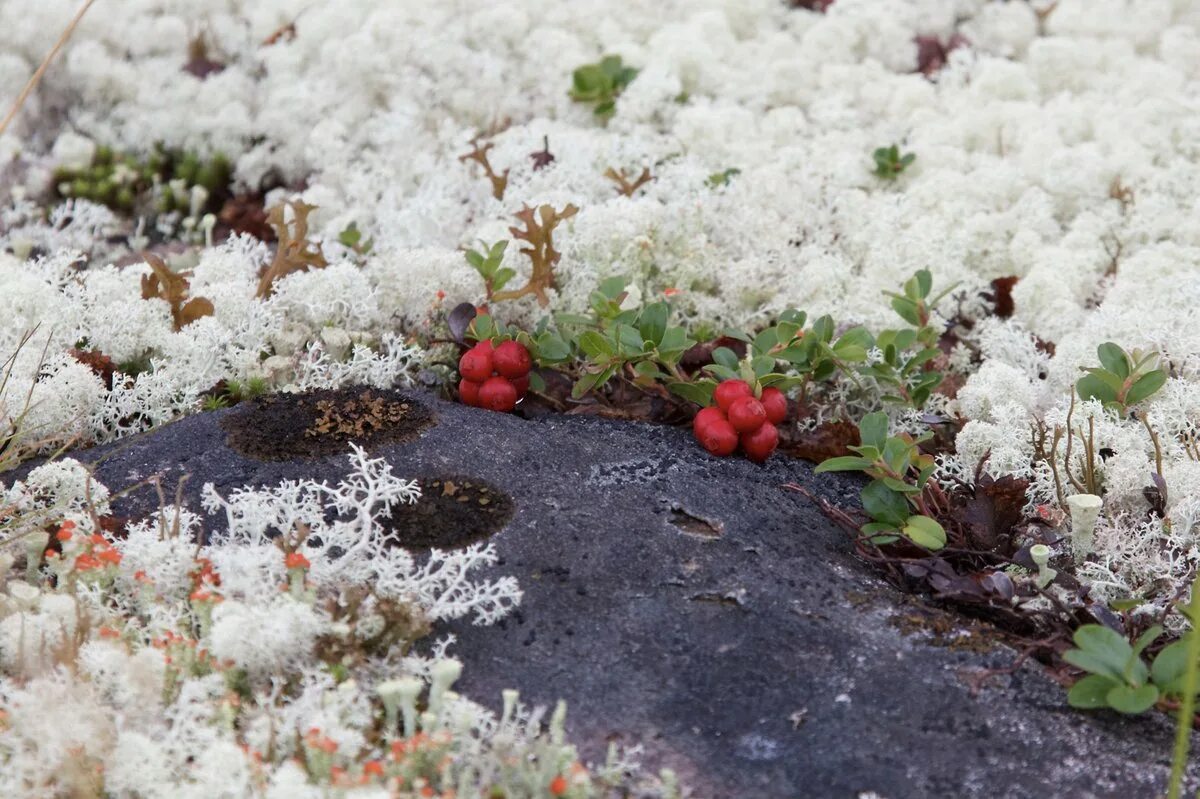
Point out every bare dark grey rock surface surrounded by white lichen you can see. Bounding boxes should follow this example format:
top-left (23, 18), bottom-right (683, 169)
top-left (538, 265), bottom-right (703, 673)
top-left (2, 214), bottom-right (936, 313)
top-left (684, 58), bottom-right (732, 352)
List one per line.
top-left (56, 398), bottom-right (1190, 799)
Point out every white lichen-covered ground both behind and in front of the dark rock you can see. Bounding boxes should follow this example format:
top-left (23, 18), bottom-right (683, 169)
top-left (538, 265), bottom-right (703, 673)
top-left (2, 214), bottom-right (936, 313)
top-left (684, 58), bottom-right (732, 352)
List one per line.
top-left (0, 0), bottom-right (1200, 797)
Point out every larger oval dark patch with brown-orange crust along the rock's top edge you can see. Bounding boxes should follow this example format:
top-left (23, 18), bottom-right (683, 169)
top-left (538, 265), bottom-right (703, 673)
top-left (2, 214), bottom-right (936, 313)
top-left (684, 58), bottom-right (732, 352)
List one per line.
top-left (221, 386), bottom-right (433, 461)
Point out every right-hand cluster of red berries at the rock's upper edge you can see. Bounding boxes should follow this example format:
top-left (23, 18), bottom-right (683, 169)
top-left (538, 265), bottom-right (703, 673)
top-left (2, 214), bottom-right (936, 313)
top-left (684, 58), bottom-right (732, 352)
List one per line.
top-left (692, 380), bottom-right (787, 463)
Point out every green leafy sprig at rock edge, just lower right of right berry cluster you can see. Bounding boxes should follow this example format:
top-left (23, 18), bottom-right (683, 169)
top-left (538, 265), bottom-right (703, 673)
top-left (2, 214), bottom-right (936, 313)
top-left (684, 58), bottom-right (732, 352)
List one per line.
top-left (816, 411), bottom-right (946, 549)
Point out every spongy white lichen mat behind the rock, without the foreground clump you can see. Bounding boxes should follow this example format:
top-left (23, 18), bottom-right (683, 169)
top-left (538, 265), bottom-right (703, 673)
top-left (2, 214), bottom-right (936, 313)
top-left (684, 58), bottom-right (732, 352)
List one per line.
top-left (0, 0), bottom-right (1200, 791)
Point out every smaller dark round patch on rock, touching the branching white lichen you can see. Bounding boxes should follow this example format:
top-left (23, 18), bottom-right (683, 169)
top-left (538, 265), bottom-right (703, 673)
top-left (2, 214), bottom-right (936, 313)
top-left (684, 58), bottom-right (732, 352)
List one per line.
top-left (384, 476), bottom-right (516, 552)
